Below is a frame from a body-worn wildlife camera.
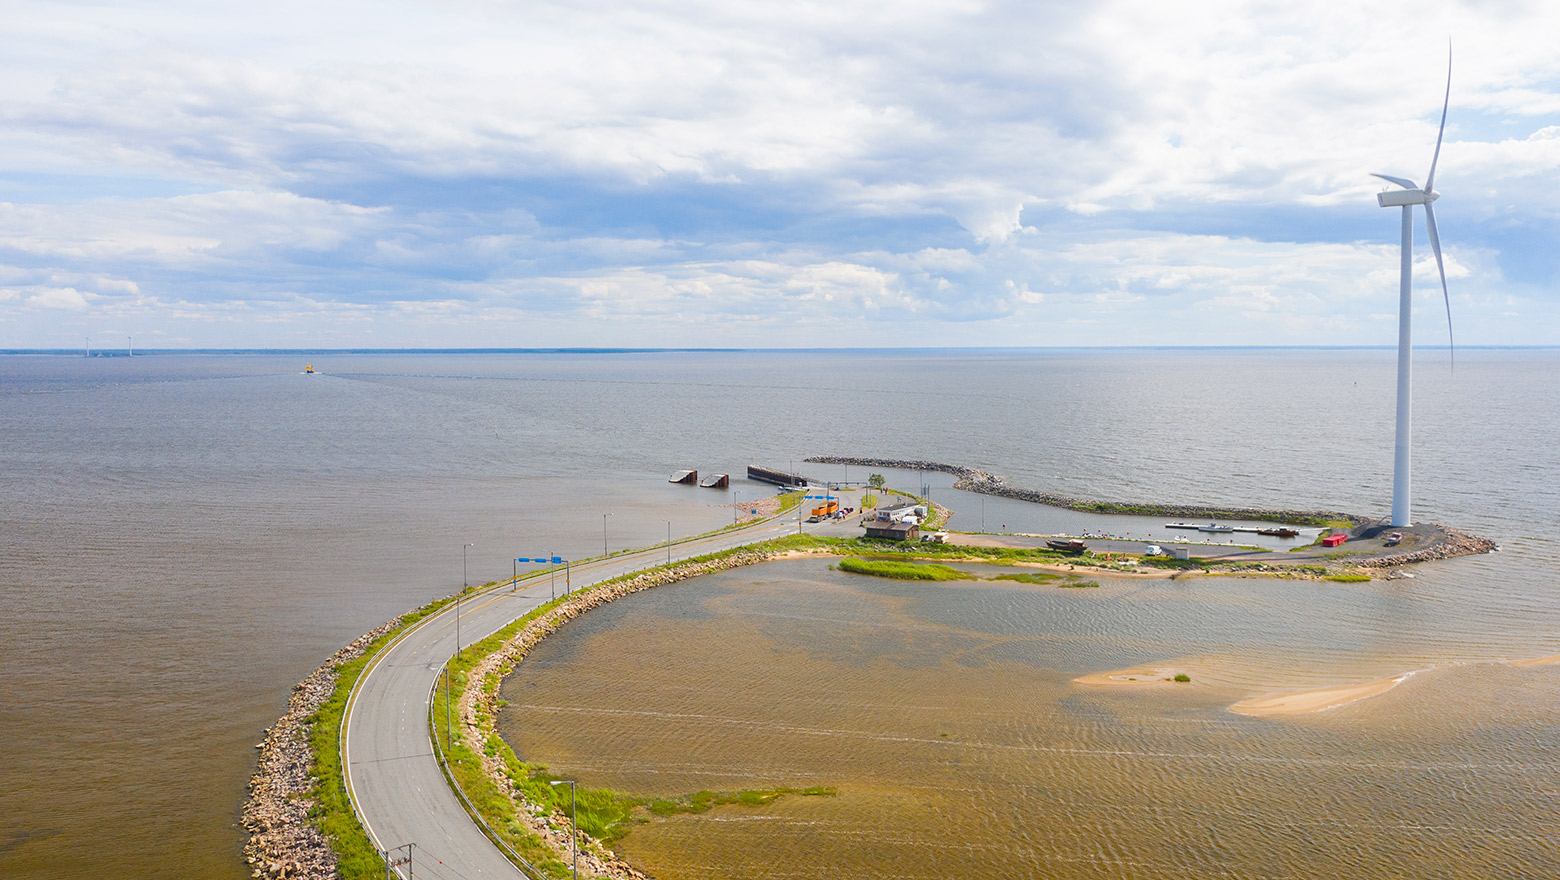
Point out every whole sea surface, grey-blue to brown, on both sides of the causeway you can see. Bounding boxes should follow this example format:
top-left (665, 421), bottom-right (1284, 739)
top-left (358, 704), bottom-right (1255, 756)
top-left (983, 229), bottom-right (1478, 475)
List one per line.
top-left (0, 351), bottom-right (1560, 880)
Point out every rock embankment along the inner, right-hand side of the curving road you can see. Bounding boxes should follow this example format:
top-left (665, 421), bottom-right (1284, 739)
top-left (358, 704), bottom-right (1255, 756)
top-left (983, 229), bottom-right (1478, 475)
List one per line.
top-left (456, 551), bottom-right (777, 880)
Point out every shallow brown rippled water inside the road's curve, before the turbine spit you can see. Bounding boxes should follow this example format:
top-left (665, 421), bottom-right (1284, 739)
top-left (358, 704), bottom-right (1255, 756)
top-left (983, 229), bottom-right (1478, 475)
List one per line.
top-left (501, 560), bottom-right (1560, 880)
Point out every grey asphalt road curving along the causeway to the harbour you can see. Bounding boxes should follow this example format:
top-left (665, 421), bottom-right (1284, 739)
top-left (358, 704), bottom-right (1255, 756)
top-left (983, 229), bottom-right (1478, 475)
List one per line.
top-left (342, 502), bottom-right (855, 880)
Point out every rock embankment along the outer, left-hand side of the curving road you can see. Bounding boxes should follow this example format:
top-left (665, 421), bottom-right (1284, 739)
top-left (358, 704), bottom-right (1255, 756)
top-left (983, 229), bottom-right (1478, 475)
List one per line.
top-left (242, 618), bottom-right (401, 880)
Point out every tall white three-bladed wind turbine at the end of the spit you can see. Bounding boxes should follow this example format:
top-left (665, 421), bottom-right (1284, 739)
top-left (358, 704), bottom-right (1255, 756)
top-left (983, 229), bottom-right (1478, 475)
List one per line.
top-left (1371, 44), bottom-right (1455, 526)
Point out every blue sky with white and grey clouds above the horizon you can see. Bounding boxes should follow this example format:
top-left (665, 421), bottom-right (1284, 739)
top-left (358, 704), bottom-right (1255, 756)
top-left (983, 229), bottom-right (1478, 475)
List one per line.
top-left (0, 0), bottom-right (1560, 348)
